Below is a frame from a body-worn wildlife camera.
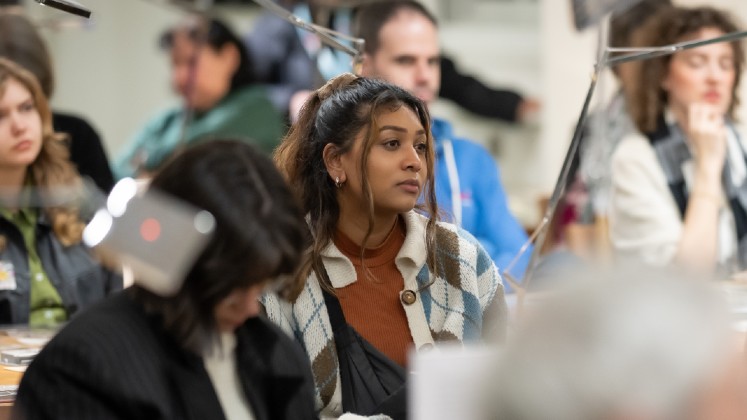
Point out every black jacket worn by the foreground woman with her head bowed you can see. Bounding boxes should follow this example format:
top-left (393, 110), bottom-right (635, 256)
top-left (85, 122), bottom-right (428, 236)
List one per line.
top-left (13, 290), bottom-right (316, 420)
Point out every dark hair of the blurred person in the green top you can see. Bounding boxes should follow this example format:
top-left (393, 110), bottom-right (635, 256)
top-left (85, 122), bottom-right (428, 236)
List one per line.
top-left (159, 15), bottom-right (257, 92)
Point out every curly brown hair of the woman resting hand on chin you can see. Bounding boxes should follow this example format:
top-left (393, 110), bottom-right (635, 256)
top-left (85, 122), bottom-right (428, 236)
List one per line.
top-left (626, 7), bottom-right (744, 133)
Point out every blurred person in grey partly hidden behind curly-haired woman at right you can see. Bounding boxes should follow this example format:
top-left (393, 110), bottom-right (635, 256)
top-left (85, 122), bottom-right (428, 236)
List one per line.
top-left (546, 0), bottom-right (672, 261)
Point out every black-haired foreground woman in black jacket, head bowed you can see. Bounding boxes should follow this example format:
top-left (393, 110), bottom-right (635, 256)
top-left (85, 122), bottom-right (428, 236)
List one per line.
top-left (13, 139), bottom-right (317, 420)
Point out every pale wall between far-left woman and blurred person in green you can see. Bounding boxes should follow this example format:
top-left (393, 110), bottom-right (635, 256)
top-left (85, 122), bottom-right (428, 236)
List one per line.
top-left (31, 0), bottom-right (177, 157)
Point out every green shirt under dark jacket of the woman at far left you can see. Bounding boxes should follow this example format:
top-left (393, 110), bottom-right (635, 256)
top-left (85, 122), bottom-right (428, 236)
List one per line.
top-left (0, 208), bottom-right (67, 326)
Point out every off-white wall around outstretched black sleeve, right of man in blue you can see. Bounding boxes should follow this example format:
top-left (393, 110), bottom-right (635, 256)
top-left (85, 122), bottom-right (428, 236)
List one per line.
top-left (431, 1), bottom-right (544, 225)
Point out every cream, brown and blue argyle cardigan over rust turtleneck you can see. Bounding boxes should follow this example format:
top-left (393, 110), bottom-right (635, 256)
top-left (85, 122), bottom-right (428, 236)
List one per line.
top-left (262, 211), bottom-right (507, 417)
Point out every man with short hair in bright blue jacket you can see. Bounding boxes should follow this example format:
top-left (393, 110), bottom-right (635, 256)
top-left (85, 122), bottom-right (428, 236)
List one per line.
top-left (354, 0), bottom-right (531, 290)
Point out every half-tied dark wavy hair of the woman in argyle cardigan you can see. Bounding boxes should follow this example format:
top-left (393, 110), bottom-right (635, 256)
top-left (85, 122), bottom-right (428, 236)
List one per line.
top-left (275, 73), bottom-right (440, 296)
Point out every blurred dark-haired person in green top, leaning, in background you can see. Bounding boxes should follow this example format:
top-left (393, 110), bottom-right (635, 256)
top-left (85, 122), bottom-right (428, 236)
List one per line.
top-left (114, 15), bottom-right (285, 178)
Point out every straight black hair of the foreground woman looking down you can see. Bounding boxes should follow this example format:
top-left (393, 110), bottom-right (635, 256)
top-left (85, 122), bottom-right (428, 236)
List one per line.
top-left (133, 140), bottom-right (308, 351)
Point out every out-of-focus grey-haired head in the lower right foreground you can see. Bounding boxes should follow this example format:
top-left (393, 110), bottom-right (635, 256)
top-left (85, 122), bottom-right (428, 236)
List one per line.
top-left (486, 267), bottom-right (734, 420)
